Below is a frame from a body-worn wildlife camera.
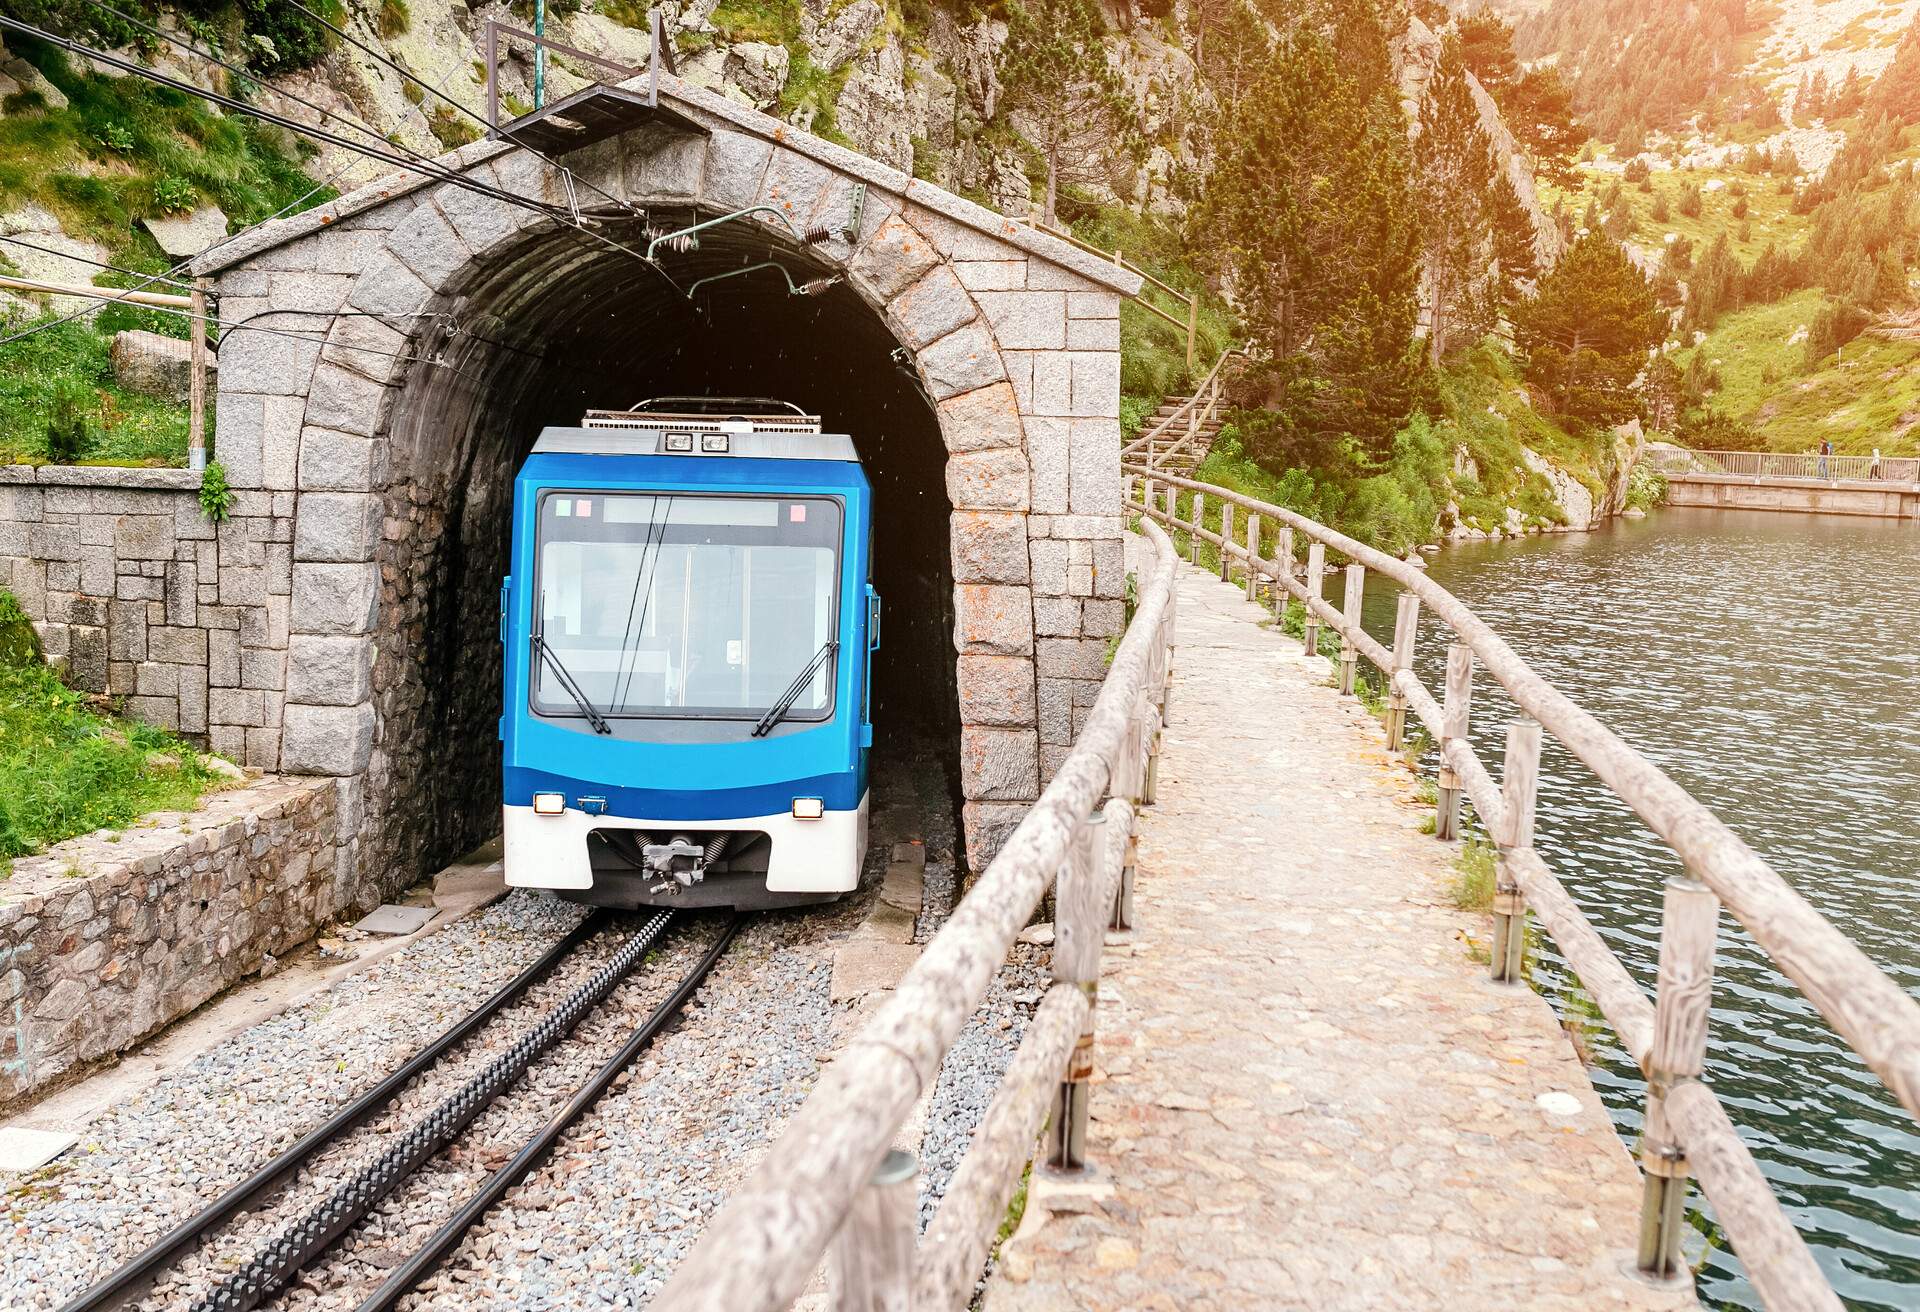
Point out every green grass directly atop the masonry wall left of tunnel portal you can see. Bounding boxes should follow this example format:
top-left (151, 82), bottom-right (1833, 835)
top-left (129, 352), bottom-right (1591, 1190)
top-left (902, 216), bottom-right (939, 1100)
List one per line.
top-left (0, 307), bottom-right (186, 465)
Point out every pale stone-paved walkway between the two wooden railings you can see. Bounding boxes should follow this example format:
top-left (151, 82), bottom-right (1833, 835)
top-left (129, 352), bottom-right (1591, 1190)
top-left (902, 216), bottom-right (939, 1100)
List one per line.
top-left (985, 567), bottom-right (1693, 1312)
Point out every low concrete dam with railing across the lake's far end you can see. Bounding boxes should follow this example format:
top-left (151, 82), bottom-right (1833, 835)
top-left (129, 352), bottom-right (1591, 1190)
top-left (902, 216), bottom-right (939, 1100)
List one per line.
top-left (1647, 446), bottom-right (1920, 521)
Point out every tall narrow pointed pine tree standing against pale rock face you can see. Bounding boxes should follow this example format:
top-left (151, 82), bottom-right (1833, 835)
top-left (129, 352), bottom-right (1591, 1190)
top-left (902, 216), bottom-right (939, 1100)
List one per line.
top-left (1413, 36), bottom-right (1500, 365)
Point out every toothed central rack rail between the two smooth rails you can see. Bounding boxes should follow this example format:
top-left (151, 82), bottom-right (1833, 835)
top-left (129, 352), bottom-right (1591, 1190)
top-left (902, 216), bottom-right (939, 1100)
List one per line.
top-left (192, 911), bottom-right (674, 1312)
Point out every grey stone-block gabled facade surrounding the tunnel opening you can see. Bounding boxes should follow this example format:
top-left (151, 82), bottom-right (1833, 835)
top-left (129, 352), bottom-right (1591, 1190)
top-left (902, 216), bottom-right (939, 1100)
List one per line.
top-left (196, 79), bottom-right (1125, 882)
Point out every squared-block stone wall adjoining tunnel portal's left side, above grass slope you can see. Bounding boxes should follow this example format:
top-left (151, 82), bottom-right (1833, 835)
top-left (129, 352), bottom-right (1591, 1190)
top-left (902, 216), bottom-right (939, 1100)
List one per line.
top-left (0, 465), bottom-right (294, 770)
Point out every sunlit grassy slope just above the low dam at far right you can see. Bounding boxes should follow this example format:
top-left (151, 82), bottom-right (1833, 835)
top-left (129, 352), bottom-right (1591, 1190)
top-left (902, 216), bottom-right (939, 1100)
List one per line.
top-left (1678, 290), bottom-right (1920, 455)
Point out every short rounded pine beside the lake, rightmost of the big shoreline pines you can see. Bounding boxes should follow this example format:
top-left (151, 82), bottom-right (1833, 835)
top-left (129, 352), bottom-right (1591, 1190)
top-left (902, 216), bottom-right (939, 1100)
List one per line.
top-left (1513, 232), bottom-right (1665, 425)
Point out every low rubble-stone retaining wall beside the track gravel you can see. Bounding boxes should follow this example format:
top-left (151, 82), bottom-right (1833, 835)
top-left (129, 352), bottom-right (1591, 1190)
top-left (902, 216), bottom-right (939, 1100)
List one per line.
top-left (0, 778), bottom-right (351, 1106)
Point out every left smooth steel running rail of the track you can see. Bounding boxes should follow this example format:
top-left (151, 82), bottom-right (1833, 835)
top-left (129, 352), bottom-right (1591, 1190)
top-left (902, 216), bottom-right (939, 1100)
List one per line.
top-left (60, 912), bottom-right (605, 1312)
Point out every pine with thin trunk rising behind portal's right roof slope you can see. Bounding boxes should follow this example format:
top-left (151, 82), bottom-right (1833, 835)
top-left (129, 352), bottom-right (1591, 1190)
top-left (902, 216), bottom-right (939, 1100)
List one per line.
top-left (1000, 0), bottom-right (1133, 225)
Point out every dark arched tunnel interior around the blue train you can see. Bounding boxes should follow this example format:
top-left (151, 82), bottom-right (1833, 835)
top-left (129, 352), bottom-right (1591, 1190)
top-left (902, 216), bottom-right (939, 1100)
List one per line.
top-left (369, 209), bottom-right (960, 872)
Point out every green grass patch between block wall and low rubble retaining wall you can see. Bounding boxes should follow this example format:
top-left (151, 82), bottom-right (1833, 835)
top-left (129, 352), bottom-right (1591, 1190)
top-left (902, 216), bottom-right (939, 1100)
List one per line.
top-left (0, 630), bottom-right (217, 863)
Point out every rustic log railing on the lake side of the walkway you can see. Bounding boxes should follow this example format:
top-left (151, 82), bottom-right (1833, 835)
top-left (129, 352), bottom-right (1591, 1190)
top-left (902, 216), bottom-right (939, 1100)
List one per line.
top-left (1127, 465), bottom-right (1920, 1312)
